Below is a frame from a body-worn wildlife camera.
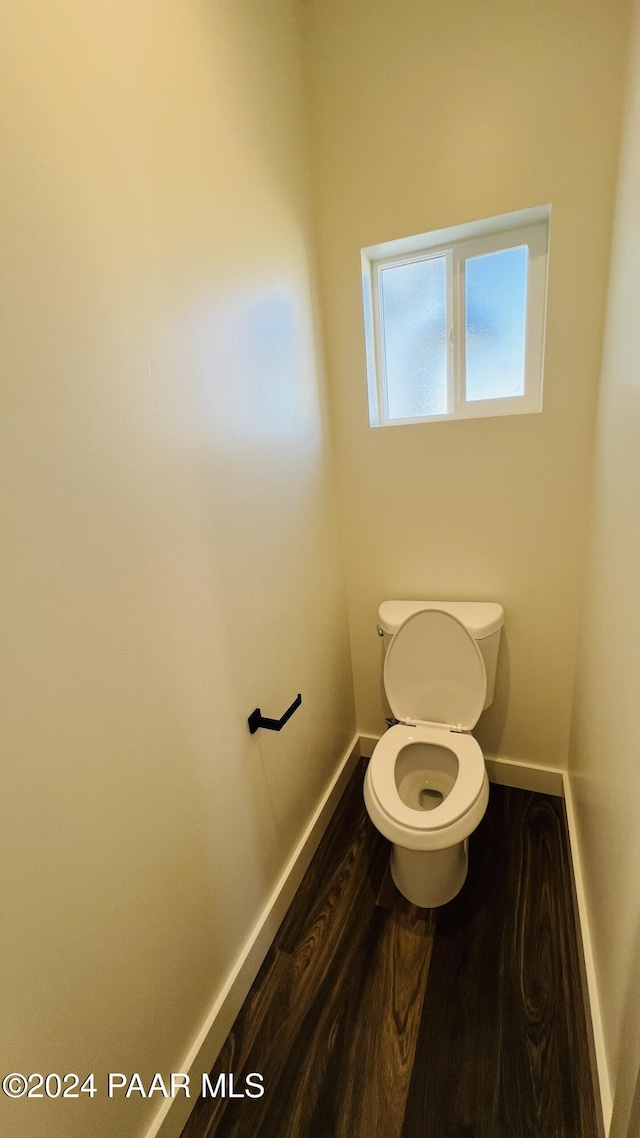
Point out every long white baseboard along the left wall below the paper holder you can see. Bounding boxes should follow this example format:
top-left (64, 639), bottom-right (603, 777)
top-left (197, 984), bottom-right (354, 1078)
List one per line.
top-left (146, 735), bottom-right (360, 1138)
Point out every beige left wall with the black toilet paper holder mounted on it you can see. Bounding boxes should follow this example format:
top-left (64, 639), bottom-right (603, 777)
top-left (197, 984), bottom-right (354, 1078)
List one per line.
top-left (0, 0), bottom-right (354, 1138)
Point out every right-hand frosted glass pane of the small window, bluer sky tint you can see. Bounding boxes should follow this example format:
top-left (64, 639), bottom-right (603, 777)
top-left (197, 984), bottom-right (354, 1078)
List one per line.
top-left (465, 245), bottom-right (528, 401)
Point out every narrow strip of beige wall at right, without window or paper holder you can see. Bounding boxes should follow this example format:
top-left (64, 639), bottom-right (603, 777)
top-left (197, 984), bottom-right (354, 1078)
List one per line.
top-left (569, 7), bottom-right (640, 1138)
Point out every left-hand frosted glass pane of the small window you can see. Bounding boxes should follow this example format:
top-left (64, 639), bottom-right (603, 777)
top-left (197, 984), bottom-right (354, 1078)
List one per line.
top-left (380, 257), bottom-right (446, 419)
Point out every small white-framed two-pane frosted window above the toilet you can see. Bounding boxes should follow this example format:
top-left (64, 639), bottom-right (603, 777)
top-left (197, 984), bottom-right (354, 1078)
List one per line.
top-left (362, 206), bottom-right (550, 427)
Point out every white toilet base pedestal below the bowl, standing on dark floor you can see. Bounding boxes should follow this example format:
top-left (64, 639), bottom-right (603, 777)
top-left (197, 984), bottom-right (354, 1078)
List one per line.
top-left (391, 838), bottom-right (469, 909)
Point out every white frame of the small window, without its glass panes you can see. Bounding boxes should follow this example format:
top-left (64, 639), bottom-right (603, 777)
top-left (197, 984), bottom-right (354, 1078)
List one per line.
top-left (362, 206), bottom-right (551, 427)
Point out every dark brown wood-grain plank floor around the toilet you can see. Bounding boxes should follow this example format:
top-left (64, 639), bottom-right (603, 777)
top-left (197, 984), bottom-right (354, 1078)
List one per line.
top-left (182, 764), bottom-right (599, 1138)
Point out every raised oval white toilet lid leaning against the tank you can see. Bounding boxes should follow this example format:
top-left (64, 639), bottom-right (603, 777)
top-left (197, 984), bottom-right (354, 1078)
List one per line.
top-left (384, 609), bottom-right (486, 731)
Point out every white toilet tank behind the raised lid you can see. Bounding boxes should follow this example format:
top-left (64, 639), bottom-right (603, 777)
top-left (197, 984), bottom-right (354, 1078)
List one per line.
top-left (378, 601), bottom-right (504, 710)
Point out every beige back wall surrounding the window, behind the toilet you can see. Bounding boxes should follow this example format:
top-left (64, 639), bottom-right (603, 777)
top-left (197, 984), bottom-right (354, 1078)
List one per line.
top-left (304, 0), bottom-right (629, 765)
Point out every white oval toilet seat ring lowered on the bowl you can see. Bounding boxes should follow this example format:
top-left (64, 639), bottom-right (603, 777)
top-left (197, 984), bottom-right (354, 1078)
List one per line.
top-left (364, 724), bottom-right (489, 850)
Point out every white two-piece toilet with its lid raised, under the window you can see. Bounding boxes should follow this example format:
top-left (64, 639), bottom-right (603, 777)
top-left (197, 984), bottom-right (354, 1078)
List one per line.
top-left (364, 601), bottom-right (504, 908)
